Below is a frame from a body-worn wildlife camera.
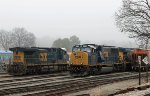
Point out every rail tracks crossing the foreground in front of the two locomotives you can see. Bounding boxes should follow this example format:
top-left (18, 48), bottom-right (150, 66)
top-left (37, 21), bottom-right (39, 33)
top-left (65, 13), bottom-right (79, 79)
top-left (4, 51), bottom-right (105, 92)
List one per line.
top-left (0, 72), bottom-right (143, 96)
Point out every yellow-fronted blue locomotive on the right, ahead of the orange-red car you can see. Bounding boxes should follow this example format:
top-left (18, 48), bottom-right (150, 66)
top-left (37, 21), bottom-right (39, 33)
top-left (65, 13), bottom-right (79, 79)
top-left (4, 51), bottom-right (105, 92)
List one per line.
top-left (69, 44), bottom-right (131, 76)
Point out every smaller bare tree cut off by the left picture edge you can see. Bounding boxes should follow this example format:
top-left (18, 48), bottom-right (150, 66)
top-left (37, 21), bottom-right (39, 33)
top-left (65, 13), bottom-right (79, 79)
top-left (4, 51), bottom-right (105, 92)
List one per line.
top-left (0, 30), bottom-right (13, 50)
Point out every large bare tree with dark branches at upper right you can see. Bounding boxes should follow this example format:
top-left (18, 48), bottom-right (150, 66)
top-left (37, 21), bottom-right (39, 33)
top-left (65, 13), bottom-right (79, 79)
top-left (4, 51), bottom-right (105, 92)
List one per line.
top-left (116, 0), bottom-right (150, 49)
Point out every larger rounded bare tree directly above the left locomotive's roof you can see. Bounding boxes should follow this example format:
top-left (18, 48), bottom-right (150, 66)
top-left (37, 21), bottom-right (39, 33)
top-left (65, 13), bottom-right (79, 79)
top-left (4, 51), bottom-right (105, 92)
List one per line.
top-left (12, 28), bottom-right (36, 47)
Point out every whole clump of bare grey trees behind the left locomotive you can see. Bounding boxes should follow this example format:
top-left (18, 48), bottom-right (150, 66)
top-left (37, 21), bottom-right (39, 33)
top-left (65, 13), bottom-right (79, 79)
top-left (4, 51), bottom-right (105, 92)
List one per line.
top-left (0, 28), bottom-right (36, 50)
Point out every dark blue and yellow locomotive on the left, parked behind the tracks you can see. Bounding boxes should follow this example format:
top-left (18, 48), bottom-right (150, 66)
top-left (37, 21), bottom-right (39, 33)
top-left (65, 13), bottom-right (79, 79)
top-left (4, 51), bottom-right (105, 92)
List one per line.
top-left (8, 47), bottom-right (68, 75)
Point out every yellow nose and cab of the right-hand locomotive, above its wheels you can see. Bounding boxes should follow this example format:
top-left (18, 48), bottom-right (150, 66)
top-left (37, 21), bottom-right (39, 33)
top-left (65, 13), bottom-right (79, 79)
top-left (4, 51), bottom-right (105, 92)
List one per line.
top-left (70, 44), bottom-right (104, 65)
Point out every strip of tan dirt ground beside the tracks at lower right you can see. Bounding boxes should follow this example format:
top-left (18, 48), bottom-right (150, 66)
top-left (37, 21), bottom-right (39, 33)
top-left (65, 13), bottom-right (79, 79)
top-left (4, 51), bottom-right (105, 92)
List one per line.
top-left (65, 79), bottom-right (150, 96)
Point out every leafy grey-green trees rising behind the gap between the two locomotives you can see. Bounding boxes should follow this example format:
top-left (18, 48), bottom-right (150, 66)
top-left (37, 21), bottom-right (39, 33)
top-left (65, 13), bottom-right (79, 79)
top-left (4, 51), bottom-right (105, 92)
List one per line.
top-left (52, 35), bottom-right (81, 51)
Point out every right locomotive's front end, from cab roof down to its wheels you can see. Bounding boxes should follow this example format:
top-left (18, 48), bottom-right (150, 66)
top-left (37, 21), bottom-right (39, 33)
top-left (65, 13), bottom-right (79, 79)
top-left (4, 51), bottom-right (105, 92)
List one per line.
top-left (70, 44), bottom-right (104, 76)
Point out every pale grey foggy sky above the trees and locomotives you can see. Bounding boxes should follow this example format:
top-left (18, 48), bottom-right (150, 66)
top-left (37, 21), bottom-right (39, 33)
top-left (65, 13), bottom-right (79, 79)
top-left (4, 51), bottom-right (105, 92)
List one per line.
top-left (0, 0), bottom-right (133, 47)
